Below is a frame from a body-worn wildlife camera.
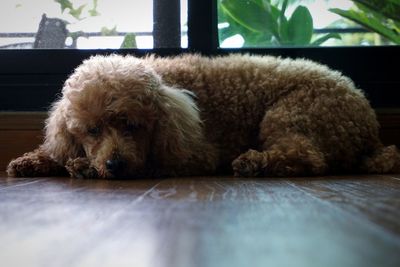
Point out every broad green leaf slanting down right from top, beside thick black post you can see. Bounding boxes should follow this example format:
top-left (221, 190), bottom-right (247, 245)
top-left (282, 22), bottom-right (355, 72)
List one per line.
top-left (221, 0), bottom-right (278, 34)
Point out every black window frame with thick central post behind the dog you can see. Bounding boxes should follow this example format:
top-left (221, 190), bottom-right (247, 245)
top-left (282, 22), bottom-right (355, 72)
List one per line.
top-left (0, 0), bottom-right (400, 111)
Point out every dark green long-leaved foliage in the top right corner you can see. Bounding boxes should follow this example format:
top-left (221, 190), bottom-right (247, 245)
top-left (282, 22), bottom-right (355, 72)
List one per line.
top-left (330, 0), bottom-right (400, 44)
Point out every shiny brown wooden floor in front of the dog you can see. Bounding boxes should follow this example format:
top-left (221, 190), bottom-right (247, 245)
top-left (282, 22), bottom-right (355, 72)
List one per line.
top-left (0, 174), bottom-right (400, 267)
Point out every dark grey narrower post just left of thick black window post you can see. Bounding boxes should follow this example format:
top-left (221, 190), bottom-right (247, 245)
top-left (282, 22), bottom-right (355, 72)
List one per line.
top-left (153, 0), bottom-right (181, 48)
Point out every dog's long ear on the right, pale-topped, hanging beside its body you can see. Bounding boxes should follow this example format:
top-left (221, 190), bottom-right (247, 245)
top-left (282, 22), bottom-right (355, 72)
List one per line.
top-left (152, 85), bottom-right (203, 170)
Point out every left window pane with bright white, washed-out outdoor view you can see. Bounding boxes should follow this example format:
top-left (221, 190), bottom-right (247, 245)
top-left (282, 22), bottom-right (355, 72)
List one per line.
top-left (0, 0), bottom-right (187, 49)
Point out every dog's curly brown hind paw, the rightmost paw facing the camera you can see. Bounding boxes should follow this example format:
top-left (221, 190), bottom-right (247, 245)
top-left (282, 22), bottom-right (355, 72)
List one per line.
top-left (232, 149), bottom-right (262, 177)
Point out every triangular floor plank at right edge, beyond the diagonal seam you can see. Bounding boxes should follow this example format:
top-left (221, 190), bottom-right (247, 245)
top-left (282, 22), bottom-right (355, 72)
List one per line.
top-left (289, 175), bottom-right (400, 235)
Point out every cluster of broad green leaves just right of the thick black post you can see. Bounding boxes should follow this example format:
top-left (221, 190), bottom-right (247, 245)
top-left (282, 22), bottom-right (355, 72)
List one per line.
top-left (218, 0), bottom-right (340, 47)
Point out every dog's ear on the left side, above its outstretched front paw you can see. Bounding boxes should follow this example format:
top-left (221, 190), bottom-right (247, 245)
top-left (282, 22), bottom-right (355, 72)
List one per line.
top-left (41, 99), bottom-right (83, 165)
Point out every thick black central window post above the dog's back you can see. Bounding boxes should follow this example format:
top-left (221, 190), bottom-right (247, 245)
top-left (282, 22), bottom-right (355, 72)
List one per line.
top-left (188, 0), bottom-right (218, 54)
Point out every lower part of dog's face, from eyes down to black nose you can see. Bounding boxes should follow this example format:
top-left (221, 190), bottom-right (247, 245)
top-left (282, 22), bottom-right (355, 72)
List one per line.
top-left (67, 101), bottom-right (154, 178)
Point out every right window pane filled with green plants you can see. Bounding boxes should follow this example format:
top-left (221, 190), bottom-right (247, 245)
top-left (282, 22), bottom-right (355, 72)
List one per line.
top-left (218, 0), bottom-right (400, 47)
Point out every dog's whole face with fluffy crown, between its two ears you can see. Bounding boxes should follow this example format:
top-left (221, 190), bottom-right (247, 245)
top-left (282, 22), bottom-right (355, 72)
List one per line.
top-left (64, 56), bottom-right (161, 178)
